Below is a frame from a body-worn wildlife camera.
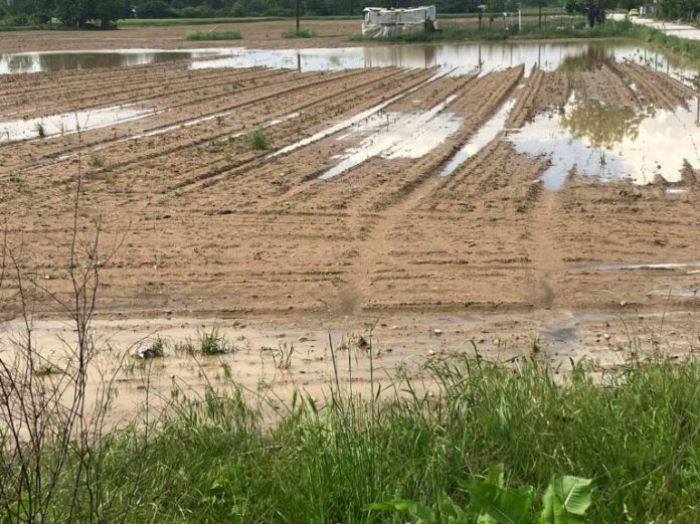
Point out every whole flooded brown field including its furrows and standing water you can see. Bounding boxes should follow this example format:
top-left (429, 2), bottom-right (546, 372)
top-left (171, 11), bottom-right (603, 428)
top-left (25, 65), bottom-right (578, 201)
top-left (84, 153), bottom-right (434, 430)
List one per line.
top-left (0, 36), bottom-right (700, 414)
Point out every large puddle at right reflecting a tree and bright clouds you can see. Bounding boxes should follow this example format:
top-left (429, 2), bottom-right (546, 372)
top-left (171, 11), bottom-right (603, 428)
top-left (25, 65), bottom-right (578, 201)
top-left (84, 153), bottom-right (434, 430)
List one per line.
top-left (508, 93), bottom-right (700, 189)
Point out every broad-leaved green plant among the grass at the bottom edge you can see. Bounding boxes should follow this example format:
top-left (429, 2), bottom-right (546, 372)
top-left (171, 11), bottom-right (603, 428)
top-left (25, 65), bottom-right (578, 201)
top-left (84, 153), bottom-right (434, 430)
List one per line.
top-left (367, 464), bottom-right (592, 524)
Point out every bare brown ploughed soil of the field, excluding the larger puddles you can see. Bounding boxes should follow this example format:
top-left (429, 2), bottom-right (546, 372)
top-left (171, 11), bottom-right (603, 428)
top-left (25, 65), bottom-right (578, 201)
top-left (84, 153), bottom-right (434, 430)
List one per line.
top-left (0, 35), bottom-right (700, 422)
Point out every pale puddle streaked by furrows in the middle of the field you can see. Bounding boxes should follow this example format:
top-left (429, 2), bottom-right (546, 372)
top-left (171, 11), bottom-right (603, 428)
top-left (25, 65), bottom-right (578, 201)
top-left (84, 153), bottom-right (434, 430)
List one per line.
top-left (319, 95), bottom-right (463, 180)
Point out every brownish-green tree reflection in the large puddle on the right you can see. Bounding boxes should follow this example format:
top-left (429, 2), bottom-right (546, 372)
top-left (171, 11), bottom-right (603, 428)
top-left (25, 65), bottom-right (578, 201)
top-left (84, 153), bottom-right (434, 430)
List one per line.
top-left (561, 100), bottom-right (654, 149)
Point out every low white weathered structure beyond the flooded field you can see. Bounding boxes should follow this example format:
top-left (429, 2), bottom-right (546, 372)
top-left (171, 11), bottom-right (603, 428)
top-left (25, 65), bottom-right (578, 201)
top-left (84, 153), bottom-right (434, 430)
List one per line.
top-left (362, 5), bottom-right (437, 38)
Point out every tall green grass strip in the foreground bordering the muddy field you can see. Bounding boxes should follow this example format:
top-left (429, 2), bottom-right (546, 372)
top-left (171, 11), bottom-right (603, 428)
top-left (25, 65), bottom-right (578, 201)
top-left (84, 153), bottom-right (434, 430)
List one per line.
top-left (6, 356), bottom-right (700, 524)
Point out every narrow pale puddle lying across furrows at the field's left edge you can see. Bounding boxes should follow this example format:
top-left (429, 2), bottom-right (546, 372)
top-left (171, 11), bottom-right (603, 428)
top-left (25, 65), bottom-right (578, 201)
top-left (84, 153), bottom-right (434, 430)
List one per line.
top-left (0, 106), bottom-right (154, 143)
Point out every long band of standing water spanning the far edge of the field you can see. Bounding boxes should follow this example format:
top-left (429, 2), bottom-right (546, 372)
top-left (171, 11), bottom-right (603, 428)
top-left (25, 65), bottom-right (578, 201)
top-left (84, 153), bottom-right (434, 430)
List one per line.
top-left (0, 42), bottom-right (695, 82)
